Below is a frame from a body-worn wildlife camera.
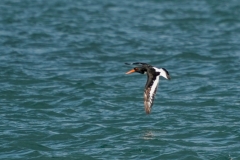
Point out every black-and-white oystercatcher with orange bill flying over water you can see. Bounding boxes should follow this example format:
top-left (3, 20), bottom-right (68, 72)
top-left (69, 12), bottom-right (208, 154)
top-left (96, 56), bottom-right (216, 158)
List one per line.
top-left (125, 62), bottom-right (171, 114)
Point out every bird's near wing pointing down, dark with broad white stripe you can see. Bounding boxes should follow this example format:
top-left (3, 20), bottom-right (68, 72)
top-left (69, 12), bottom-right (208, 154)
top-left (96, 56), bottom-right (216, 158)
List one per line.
top-left (144, 75), bottom-right (159, 114)
